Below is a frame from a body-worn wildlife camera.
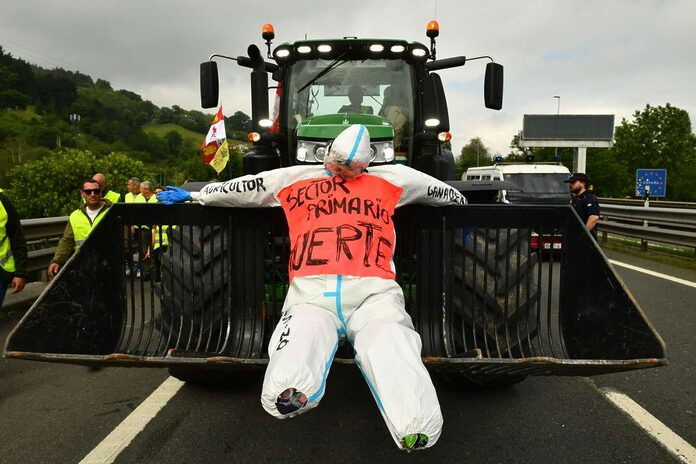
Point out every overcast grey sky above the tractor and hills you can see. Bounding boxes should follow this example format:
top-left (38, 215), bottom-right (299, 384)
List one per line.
top-left (0, 0), bottom-right (696, 154)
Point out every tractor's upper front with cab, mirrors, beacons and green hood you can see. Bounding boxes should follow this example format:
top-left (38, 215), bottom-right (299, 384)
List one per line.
top-left (201, 21), bottom-right (503, 180)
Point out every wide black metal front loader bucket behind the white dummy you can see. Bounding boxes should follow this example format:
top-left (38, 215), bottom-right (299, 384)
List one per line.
top-left (4, 204), bottom-right (666, 383)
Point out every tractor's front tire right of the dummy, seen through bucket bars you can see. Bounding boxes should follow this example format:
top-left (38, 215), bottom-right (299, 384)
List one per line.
top-left (447, 229), bottom-right (539, 358)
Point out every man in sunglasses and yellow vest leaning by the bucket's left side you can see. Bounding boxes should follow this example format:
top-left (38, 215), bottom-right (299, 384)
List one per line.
top-left (48, 179), bottom-right (111, 277)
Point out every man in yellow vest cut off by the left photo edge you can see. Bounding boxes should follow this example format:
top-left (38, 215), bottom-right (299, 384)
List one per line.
top-left (0, 189), bottom-right (27, 306)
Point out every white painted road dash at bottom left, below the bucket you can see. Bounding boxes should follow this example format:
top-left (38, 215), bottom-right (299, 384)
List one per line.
top-left (80, 377), bottom-right (184, 464)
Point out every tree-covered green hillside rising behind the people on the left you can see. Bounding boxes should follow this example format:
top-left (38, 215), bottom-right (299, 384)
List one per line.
top-left (0, 45), bottom-right (258, 218)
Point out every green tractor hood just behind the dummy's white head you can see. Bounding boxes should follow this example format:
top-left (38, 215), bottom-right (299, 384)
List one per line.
top-left (297, 113), bottom-right (394, 141)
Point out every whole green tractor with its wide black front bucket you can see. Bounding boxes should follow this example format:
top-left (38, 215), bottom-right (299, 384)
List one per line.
top-left (4, 21), bottom-right (666, 386)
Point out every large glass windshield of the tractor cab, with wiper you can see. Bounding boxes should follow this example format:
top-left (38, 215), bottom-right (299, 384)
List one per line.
top-left (284, 59), bottom-right (413, 151)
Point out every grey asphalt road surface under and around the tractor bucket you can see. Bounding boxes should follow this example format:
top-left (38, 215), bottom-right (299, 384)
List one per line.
top-left (0, 250), bottom-right (696, 464)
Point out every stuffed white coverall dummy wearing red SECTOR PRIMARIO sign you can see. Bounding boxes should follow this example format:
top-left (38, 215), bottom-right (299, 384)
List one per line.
top-left (192, 126), bottom-right (466, 447)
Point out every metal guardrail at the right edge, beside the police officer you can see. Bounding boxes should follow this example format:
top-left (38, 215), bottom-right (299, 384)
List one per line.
top-left (599, 200), bottom-right (696, 249)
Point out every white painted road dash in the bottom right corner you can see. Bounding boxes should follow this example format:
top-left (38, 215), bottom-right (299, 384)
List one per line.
top-left (598, 388), bottom-right (696, 464)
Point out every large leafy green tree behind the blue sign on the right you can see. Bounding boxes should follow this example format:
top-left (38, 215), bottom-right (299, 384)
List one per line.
top-left (614, 103), bottom-right (696, 200)
